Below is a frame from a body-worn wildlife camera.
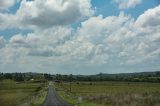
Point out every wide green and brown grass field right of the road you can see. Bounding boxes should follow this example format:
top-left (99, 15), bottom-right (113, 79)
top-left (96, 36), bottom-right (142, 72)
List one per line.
top-left (55, 82), bottom-right (160, 106)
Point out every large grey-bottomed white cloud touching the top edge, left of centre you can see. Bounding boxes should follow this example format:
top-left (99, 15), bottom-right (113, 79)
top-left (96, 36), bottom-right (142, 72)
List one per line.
top-left (0, 0), bottom-right (94, 28)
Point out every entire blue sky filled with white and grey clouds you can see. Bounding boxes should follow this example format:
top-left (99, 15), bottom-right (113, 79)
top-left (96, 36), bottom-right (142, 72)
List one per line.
top-left (0, 0), bottom-right (160, 75)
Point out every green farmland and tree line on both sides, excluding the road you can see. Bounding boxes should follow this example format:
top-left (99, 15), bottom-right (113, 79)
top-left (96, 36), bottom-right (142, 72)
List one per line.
top-left (0, 72), bottom-right (160, 106)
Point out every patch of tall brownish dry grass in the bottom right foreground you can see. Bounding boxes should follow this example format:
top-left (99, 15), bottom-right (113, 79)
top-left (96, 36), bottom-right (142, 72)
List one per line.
top-left (83, 92), bottom-right (160, 106)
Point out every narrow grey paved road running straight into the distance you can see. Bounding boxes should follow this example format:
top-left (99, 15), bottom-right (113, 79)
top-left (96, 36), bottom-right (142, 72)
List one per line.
top-left (43, 83), bottom-right (71, 106)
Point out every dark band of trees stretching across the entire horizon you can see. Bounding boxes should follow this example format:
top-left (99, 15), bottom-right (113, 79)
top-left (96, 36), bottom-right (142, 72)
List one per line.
top-left (0, 71), bottom-right (160, 82)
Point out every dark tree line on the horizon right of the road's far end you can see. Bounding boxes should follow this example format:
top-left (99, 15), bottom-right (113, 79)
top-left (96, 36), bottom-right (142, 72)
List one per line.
top-left (55, 71), bottom-right (160, 83)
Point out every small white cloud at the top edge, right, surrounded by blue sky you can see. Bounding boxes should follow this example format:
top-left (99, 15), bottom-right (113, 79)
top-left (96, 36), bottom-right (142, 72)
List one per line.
top-left (113, 0), bottom-right (142, 9)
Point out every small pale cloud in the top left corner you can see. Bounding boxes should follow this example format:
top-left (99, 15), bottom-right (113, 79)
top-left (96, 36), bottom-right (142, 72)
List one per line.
top-left (0, 0), bottom-right (16, 11)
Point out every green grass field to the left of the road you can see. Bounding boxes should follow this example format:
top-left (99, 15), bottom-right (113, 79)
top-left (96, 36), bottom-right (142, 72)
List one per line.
top-left (0, 80), bottom-right (47, 106)
